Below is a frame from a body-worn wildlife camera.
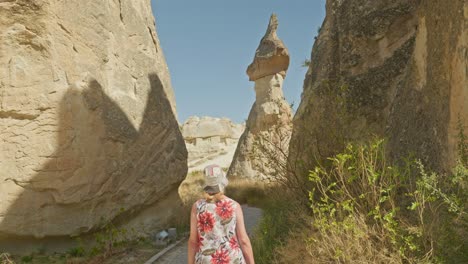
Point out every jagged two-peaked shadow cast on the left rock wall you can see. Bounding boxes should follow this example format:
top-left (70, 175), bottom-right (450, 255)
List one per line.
top-left (0, 74), bottom-right (187, 251)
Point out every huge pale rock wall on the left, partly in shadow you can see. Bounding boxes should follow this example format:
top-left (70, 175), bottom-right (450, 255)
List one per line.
top-left (0, 0), bottom-right (187, 245)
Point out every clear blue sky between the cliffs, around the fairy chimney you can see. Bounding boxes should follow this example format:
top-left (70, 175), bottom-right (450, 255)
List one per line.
top-left (151, 0), bottom-right (325, 122)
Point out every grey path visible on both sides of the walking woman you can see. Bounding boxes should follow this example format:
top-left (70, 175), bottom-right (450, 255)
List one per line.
top-left (154, 205), bottom-right (262, 264)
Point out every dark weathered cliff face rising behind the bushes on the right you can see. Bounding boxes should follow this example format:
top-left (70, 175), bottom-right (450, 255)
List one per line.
top-left (289, 0), bottom-right (468, 175)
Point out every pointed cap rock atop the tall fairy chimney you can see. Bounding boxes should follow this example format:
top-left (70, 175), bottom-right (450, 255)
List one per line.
top-left (247, 14), bottom-right (289, 81)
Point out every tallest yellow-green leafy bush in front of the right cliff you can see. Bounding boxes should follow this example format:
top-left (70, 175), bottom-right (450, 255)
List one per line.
top-left (309, 140), bottom-right (418, 262)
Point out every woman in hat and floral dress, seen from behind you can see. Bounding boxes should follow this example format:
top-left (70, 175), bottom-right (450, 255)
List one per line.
top-left (188, 165), bottom-right (255, 264)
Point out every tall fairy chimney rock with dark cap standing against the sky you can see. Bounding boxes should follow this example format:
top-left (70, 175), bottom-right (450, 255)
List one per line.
top-left (228, 15), bottom-right (292, 180)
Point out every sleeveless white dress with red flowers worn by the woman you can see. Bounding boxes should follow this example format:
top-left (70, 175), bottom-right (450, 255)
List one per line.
top-left (195, 198), bottom-right (245, 264)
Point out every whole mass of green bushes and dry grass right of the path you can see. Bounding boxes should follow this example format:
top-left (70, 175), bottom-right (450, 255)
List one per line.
top-left (252, 140), bottom-right (468, 263)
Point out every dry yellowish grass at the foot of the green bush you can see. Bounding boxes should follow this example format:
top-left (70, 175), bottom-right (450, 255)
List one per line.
top-left (272, 214), bottom-right (407, 264)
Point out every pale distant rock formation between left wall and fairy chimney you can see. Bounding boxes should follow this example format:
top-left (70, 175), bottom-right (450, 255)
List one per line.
top-left (181, 116), bottom-right (245, 172)
